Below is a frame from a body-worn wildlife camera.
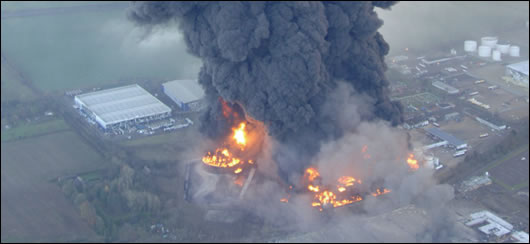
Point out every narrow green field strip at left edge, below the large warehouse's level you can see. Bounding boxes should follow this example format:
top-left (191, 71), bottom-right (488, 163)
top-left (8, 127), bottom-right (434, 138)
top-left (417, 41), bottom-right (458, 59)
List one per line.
top-left (2, 119), bottom-right (70, 142)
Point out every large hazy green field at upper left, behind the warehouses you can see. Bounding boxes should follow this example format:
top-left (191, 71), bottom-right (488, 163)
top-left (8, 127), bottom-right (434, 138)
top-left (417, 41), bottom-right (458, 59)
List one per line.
top-left (1, 3), bottom-right (201, 92)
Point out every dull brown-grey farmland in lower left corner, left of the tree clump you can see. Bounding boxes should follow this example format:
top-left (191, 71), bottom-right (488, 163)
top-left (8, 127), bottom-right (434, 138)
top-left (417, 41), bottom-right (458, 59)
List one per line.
top-left (1, 131), bottom-right (107, 242)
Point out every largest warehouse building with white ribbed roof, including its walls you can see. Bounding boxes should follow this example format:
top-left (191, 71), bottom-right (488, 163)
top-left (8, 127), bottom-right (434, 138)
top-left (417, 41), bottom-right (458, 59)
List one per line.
top-left (74, 84), bottom-right (171, 130)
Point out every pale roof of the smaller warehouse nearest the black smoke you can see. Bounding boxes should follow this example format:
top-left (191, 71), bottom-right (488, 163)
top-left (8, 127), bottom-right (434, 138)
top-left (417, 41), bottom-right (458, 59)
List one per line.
top-left (162, 80), bottom-right (204, 103)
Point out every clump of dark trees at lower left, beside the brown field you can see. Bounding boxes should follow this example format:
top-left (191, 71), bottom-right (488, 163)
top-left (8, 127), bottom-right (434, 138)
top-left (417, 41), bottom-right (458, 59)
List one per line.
top-left (59, 158), bottom-right (162, 241)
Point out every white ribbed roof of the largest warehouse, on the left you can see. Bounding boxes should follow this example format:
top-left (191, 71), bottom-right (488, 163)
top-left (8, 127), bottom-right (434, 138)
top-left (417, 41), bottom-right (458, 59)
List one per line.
top-left (76, 84), bottom-right (171, 124)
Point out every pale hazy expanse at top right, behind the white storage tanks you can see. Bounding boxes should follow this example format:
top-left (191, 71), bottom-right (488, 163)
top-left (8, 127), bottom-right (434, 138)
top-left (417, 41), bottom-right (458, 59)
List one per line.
top-left (376, 1), bottom-right (529, 54)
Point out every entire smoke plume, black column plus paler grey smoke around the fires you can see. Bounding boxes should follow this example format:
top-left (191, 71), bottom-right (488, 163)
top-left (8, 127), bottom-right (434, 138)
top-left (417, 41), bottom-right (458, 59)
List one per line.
top-left (125, 2), bottom-right (478, 241)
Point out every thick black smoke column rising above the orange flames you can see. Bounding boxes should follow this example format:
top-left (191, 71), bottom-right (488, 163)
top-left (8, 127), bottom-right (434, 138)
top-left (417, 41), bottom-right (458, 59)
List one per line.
top-left (129, 1), bottom-right (402, 181)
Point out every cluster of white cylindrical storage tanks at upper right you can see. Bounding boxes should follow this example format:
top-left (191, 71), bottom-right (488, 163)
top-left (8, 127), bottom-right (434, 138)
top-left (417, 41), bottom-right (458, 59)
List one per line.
top-left (464, 36), bottom-right (520, 61)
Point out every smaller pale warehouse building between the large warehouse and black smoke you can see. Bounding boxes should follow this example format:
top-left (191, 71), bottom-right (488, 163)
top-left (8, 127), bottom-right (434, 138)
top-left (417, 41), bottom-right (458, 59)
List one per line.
top-left (162, 80), bottom-right (204, 111)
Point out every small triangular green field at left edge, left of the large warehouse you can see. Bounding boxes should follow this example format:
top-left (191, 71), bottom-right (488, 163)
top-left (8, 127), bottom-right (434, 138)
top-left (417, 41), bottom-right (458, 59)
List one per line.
top-left (1, 62), bottom-right (35, 102)
